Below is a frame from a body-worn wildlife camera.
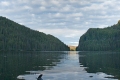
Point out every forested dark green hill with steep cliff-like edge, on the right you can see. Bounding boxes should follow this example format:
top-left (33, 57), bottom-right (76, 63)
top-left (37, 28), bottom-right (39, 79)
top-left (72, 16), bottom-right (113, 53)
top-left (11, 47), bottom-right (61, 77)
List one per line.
top-left (76, 21), bottom-right (120, 51)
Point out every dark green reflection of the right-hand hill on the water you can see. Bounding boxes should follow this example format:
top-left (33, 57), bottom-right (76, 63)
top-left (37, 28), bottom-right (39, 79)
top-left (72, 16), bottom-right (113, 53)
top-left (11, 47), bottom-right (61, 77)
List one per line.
top-left (79, 52), bottom-right (120, 79)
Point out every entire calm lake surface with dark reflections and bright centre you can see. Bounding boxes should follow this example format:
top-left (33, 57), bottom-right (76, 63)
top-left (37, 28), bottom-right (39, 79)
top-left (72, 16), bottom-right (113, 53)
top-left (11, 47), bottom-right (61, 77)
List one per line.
top-left (0, 51), bottom-right (120, 80)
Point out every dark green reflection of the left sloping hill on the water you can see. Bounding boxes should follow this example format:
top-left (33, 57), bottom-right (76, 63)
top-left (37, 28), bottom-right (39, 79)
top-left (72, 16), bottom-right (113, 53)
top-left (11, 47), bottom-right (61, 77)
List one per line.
top-left (0, 52), bottom-right (63, 80)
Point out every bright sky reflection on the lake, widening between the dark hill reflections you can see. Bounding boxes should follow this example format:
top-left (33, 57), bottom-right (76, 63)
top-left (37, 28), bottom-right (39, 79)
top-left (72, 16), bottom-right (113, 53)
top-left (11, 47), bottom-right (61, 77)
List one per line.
top-left (18, 53), bottom-right (118, 80)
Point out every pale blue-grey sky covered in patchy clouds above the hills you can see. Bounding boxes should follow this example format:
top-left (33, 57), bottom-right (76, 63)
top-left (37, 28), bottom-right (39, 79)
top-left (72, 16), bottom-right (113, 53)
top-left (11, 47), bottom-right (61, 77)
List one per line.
top-left (0, 0), bottom-right (120, 45)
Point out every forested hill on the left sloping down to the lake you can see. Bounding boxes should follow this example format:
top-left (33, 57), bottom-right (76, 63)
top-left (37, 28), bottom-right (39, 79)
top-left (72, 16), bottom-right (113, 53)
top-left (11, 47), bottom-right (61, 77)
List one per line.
top-left (0, 16), bottom-right (69, 51)
